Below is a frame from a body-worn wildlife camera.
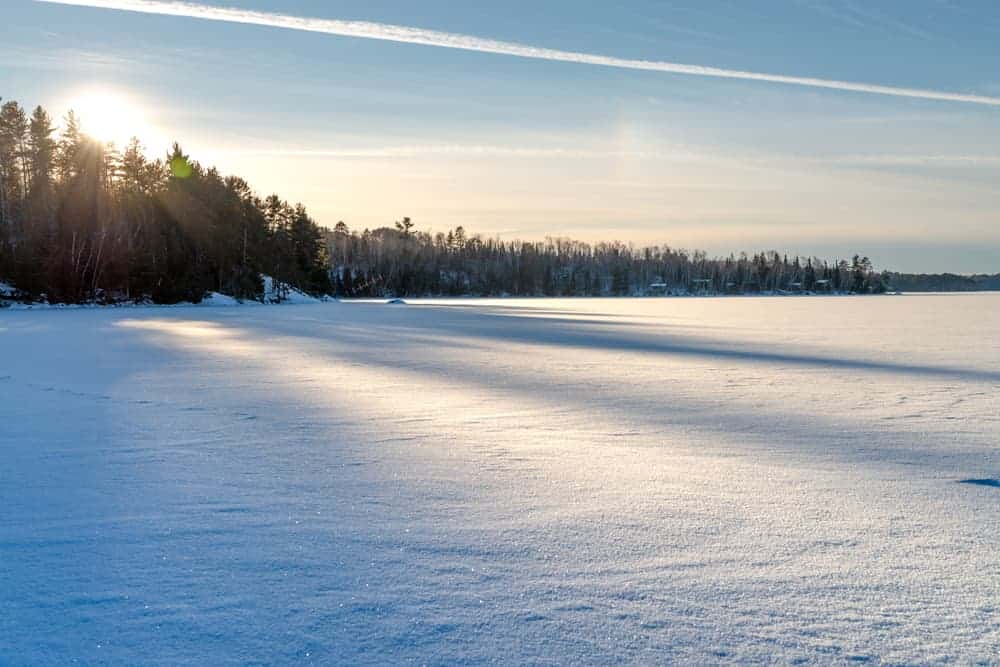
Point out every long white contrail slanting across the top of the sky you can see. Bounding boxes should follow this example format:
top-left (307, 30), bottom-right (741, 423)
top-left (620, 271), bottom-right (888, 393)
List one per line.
top-left (35, 0), bottom-right (1000, 106)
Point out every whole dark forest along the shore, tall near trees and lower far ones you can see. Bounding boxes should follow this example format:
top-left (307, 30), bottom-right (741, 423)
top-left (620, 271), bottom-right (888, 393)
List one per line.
top-left (0, 96), bottom-right (968, 303)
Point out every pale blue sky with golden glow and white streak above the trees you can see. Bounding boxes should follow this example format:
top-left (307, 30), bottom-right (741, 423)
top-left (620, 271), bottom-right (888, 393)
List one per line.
top-left (0, 0), bottom-right (1000, 273)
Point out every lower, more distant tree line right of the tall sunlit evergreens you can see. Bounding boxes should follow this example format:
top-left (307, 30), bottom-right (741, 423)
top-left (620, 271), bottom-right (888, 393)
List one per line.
top-left (326, 218), bottom-right (886, 297)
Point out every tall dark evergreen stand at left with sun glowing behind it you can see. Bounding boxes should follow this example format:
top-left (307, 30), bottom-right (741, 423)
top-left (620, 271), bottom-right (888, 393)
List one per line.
top-left (0, 101), bottom-right (331, 303)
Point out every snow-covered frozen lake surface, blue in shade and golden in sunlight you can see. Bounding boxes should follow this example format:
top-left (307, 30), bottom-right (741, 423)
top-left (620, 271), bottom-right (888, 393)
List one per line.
top-left (0, 294), bottom-right (1000, 665)
